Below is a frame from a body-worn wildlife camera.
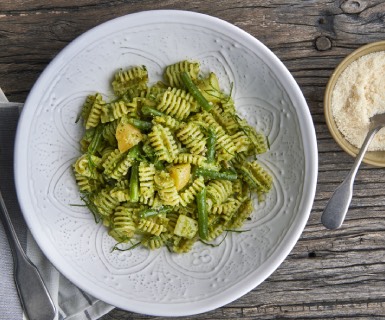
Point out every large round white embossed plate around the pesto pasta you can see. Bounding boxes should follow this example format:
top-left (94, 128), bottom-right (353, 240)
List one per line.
top-left (15, 11), bottom-right (318, 316)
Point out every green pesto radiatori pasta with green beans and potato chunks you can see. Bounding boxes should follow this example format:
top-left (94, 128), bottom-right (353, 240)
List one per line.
top-left (73, 61), bottom-right (272, 253)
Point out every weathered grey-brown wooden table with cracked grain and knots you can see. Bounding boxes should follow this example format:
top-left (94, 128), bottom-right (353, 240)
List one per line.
top-left (0, 0), bottom-right (385, 320)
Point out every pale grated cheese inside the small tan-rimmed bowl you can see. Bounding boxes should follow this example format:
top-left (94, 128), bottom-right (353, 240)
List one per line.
top-left (331, 51), bottom-right (385, 151)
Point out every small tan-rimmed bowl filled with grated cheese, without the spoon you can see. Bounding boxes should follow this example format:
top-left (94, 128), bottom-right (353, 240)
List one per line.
top-left (324, 41), bottom-right (385, 167)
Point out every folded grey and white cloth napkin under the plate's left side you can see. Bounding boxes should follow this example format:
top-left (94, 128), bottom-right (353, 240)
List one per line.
top-left (0, 89), bottom-right (114, 320)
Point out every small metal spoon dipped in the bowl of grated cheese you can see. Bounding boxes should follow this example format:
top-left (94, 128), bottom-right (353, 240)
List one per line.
top-left (321, 113), bottom-right (385, 229)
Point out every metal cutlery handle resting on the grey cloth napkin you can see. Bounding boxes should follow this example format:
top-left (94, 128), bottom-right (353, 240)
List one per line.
top-left (0, 191), bottom-right (56, 320)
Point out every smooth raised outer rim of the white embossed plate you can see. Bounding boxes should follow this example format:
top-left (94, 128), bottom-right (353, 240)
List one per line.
top-left (15, 10), bottom-right (318, 316)
